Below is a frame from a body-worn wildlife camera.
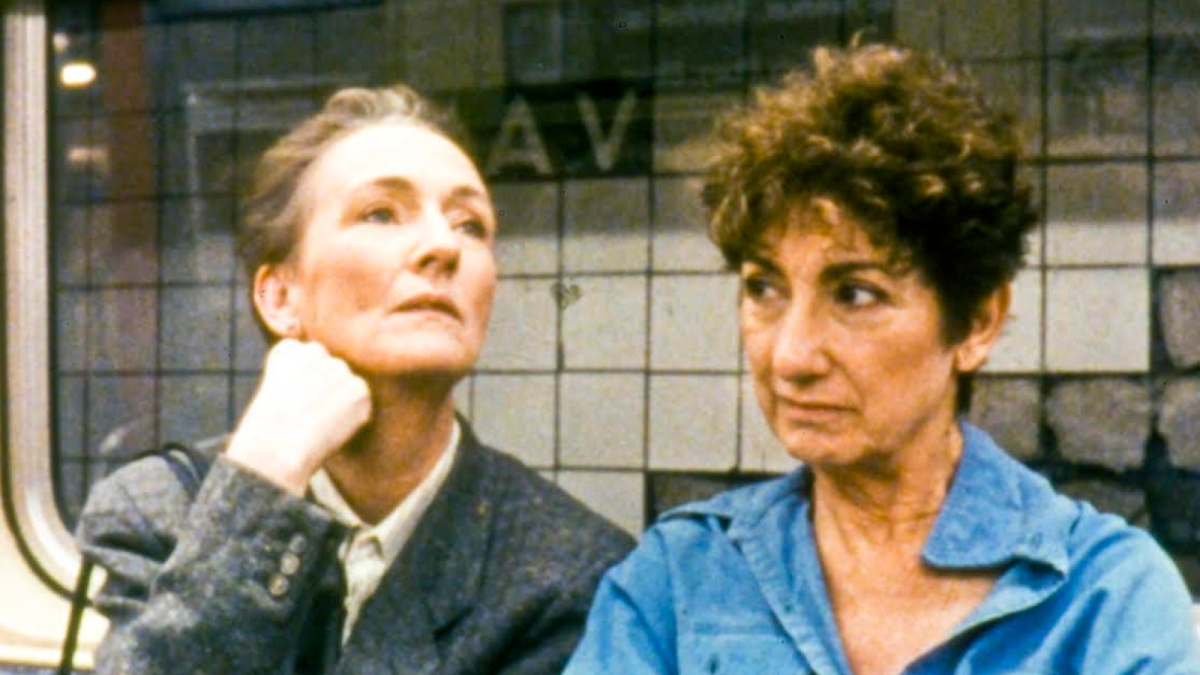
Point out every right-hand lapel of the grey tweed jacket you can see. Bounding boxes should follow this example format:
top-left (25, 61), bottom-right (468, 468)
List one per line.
top-left (337, 419), bottom-right (494, 674)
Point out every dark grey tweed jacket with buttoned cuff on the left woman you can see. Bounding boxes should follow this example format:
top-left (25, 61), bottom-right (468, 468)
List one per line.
top-left (77, 423), bottom-right (632, 675)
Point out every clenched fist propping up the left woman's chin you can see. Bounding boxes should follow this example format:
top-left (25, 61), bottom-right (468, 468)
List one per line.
top-left (226, 339), bottom-right (371, 495)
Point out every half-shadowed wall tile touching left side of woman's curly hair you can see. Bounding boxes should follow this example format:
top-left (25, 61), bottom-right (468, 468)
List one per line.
top-left (650, 177), bottom-right (725, 271)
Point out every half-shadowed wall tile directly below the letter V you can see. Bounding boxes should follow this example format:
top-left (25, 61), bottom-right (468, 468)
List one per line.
top-left (563, 178), bottom-right (650, 274)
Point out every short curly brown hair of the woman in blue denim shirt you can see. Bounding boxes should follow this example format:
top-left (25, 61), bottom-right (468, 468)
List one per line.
top-left (703, 43), bottom-right (1037, 412)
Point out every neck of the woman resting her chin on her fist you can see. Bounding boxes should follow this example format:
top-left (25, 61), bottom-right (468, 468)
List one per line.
top-left (325, 381), bottom-right (455, 525)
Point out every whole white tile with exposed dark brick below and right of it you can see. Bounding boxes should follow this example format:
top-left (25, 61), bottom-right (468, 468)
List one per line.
top-left (1045, 269), bottom-right (1150, 372)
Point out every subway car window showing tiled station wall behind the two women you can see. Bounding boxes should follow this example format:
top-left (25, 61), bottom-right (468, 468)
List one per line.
top-left (0, 0), bottom-right (1200, 673)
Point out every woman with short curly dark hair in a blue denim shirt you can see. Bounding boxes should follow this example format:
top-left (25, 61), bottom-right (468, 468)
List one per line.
top-left (568, 44), bottom-right (1200, 675)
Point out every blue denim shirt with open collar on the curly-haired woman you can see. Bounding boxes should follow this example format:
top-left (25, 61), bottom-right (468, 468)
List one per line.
top-left (566, 424), bottom-right (1200, 675)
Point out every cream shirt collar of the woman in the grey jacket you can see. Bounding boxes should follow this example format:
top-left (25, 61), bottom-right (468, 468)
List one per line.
top-left (308, 420), bottom-right (462, 566)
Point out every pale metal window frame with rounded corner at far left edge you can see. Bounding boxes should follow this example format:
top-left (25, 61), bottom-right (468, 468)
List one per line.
top-left (0, 0), bottom-right (104, 668)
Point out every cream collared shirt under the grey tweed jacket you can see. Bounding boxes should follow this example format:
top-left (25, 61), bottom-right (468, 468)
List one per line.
top-left (308, 420), bottom-right (462, 644)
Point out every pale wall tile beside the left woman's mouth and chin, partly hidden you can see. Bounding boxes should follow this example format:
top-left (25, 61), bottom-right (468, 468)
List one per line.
top-left (479, 279), bottom-right (558, 370)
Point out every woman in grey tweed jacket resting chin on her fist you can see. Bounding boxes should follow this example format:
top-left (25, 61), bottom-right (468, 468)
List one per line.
top-left (78, 86), bottom-right (632, 675)
